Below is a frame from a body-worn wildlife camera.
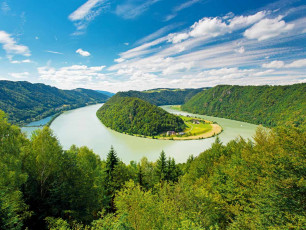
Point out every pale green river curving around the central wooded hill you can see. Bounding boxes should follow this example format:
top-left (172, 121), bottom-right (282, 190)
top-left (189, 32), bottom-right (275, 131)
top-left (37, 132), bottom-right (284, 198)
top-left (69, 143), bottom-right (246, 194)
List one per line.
top-left (22, 104), bottom-right (257, 163)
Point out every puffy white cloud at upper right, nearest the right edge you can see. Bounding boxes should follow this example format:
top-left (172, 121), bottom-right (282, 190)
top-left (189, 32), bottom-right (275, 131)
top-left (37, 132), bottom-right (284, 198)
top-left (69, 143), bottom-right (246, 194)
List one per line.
top-left (244, 16), bottom-right (294, 41)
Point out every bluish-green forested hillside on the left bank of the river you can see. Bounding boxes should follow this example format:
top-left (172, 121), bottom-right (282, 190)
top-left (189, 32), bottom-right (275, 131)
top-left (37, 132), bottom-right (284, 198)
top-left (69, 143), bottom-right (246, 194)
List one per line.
top-left (0, 81), bottom-right (109, 125)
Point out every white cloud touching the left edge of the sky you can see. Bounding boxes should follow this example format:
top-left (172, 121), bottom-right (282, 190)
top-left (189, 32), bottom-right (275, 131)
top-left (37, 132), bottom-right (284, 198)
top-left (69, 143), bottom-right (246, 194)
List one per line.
top-left (0, 31), bottom-right (31, 56)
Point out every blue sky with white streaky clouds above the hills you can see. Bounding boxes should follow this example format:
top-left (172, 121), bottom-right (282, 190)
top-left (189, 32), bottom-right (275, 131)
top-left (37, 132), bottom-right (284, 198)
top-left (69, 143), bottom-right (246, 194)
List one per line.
top-left (0, 0), bottom-right (306, 92)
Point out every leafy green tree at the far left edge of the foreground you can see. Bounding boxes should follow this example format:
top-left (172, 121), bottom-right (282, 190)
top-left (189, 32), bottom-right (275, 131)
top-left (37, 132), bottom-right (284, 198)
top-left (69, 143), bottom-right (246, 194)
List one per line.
top-left (0, 110), bottom-right (30, 229)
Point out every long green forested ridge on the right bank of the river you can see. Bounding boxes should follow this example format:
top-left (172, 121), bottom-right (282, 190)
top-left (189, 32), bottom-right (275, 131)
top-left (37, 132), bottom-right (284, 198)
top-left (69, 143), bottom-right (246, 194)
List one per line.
top-left (182, 83), bottom-right (306, 127)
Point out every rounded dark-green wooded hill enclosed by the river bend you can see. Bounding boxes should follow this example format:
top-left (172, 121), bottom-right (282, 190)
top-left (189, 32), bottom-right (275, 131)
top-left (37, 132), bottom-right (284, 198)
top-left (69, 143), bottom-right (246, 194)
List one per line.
top-left (97, 95), bottom-right (185, 136)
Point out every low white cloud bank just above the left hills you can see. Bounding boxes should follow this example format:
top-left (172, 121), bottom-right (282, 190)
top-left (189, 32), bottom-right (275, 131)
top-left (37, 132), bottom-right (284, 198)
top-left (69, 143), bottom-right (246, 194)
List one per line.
top-left (37, 65), bottom-right (105, 88)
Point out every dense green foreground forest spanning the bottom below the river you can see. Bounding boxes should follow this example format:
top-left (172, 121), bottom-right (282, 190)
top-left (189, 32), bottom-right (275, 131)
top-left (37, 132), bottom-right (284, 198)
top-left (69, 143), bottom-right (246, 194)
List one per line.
top-left (0, 112), bottom-right (306, 230)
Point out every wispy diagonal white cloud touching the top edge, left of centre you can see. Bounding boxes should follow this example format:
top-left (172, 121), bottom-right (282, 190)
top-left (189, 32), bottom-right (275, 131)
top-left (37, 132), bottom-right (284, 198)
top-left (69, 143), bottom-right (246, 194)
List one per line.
top-left (68, 0), bottom-right (108, 32)
